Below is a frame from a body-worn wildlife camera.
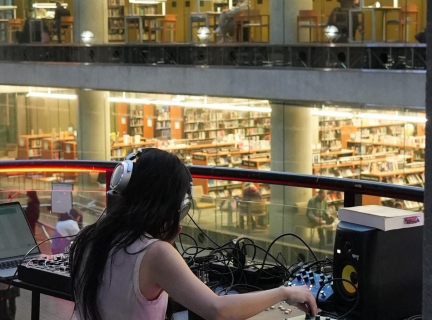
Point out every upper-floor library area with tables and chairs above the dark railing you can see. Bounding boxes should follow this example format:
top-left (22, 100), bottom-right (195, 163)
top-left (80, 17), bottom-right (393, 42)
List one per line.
top-left (0, 0), bottom-right (426, 44)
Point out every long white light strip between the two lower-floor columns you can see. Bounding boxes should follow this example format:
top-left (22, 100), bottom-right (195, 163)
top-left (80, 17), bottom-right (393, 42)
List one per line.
top-left (108, 96), bottom-right (272, 112)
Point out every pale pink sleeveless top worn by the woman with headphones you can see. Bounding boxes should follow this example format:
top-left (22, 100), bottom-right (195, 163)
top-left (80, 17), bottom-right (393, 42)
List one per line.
top-left (77, 237), bottom-right (168, 320)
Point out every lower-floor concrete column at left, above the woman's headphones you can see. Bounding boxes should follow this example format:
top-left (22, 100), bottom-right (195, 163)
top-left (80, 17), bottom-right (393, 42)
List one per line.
top-left (77, 89), bottom-right (110, 160)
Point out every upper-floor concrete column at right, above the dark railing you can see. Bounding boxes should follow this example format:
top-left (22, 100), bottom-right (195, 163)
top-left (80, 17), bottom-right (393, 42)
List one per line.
top-left (270, 0), bottom-right (313, 44)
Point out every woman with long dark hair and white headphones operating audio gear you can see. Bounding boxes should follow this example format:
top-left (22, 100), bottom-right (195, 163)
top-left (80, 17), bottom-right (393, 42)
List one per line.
top-left (70, 148), bottom-right (317, 320)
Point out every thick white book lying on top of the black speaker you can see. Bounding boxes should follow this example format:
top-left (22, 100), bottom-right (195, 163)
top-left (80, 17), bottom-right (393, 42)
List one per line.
top-left (338, 205), bottom-right (424, 231)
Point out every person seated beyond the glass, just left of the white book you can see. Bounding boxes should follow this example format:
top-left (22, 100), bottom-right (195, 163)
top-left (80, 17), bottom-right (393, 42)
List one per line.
top-left (306, 190), bottom-right (334, 245)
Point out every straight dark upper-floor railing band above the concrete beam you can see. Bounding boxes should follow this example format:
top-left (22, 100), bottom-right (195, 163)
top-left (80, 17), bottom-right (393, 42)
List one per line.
top-left (0, 43), bottom-right (426, 70)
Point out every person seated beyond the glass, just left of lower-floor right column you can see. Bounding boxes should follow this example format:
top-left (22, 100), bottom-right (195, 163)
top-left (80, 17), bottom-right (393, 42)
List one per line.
top-left (239, 183), bottom-right (267, 229)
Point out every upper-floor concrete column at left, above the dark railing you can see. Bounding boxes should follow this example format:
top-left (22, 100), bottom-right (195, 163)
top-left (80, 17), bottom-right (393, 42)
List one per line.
top-left (73, 0), bottom-right (108, 44)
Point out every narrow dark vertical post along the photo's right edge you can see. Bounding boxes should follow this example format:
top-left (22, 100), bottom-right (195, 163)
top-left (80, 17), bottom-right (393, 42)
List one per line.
top-left (422, 0), bottom-right (432, 319)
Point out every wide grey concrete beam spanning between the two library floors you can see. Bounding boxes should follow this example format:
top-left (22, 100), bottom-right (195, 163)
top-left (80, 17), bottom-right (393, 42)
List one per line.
top-left (0, 63), bottom-right (426, 108)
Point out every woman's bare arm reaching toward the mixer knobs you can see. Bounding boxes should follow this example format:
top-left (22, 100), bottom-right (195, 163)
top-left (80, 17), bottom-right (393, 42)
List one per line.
top-left (140, 241), bottom-right (317, 320)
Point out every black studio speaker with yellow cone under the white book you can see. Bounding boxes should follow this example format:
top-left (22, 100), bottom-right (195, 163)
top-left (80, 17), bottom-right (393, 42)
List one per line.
top-left (333, 222), bottom-right (423, 320)
